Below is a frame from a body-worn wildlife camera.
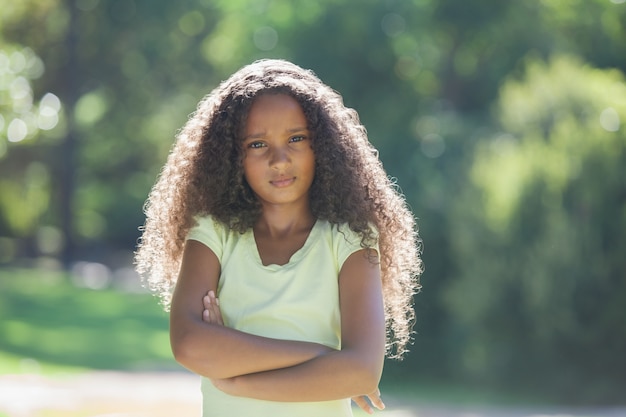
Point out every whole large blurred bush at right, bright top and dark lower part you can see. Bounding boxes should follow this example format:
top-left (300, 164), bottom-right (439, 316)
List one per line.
top-left (444, 57), bottom-right (626, 401)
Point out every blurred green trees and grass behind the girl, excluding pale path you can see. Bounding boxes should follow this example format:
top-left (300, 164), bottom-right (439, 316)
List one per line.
top-left (0, 0), bottom-right (626, 415)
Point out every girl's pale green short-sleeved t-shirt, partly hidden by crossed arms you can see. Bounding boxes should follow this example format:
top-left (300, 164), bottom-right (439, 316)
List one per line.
top-left (188, 217), bottom-right (370, 417)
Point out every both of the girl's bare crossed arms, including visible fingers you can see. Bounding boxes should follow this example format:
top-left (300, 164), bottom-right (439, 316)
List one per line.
top-left (170, 241), bottom-right (385, 411)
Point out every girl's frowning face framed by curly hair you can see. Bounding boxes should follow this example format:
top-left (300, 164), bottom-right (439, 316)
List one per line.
top-left (243, 94), bottom-right (315, 211)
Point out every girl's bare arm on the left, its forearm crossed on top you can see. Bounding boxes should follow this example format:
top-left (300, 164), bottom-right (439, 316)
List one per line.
top-left (170, 240), bottom-right (331, 379)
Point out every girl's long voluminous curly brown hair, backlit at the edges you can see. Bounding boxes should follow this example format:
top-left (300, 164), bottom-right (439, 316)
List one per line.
top-left (135, 60), bottom-right (422, 358)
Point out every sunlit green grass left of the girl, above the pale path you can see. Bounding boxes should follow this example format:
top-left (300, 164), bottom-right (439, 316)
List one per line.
top-left (0, 269), bottom-right (177, 374)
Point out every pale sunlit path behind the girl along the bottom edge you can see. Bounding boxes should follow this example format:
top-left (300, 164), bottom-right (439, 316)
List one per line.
top-left (0, 372), bottom-right (626, 417)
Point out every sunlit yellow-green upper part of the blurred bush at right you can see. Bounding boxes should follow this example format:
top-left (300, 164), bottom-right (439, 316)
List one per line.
top-left (473, 54), bottom-right (626, 228)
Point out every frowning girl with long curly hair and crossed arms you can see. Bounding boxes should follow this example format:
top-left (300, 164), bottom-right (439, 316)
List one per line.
top-left (136, 60), bottom-right (422, 417)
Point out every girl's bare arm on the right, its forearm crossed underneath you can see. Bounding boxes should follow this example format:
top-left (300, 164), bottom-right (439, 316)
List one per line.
top-left (214, 250), bottom-right (385, 402)
